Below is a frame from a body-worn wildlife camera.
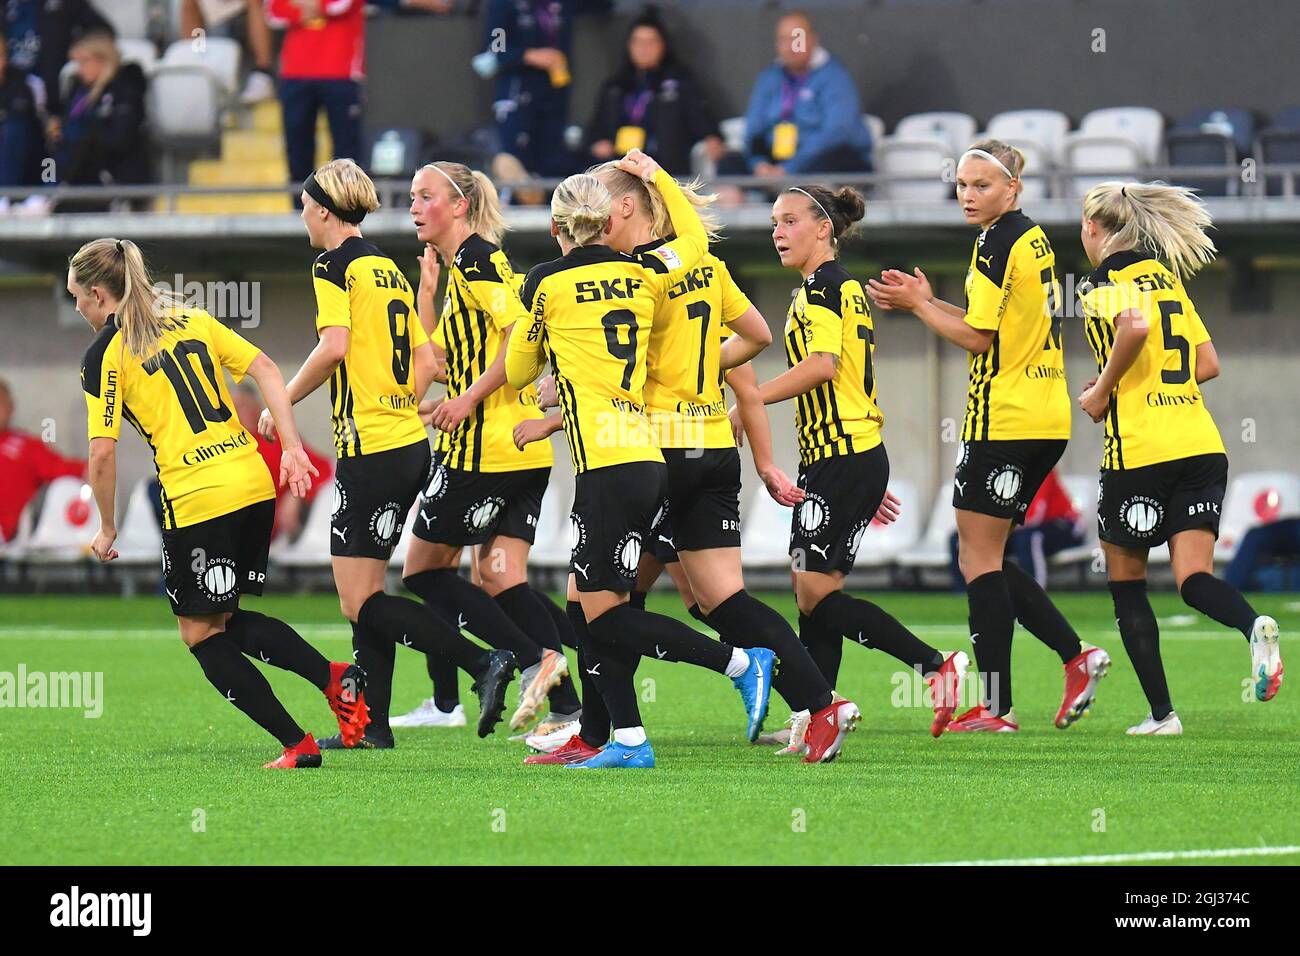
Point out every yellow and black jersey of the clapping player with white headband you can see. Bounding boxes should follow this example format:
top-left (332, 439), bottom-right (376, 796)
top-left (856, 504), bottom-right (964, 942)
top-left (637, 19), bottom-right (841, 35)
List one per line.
top-left (962, 209), bottom-right (1070, 441)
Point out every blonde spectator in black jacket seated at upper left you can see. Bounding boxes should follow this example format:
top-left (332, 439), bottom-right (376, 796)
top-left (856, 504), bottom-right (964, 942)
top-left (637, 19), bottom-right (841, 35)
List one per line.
top-left (49, 33), bottom-right (151, 211)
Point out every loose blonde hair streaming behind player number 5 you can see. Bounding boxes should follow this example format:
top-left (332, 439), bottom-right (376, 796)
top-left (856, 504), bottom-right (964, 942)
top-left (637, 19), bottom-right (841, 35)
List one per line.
top-left (1083, 182), bottom-right (1217, 280)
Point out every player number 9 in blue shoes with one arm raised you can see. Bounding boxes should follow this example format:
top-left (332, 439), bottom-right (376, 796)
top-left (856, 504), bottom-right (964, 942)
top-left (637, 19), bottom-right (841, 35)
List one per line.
top-left (506, 151), bottom-right (774, 767)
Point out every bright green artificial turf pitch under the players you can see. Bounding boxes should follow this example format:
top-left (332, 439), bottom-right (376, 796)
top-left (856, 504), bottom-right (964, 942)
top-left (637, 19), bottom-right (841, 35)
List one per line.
top-left (0, 594), bottom-right (1300, 865)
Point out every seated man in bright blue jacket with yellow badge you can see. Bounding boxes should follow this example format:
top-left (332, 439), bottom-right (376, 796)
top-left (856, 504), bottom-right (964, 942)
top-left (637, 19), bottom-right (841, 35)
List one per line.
top-left (718, 13), bottom-right (871, 178)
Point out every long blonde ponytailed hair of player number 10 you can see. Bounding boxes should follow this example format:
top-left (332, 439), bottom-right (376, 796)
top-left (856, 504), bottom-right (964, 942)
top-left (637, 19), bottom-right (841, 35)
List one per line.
top-left (68, 239), bottom-right (185, 359)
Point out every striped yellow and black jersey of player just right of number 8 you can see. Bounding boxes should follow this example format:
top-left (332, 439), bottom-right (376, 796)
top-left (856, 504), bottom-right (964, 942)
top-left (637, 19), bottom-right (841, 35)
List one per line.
top-left (433, 234), bottom-right (554, 471)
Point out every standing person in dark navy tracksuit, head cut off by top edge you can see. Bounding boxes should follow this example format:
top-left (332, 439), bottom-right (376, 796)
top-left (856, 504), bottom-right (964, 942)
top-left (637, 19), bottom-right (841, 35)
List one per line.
top-left (473, 0), bottom-right (608, 177)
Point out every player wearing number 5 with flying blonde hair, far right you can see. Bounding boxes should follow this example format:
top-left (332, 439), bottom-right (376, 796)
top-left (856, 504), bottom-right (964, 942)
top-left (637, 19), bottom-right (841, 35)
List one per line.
top-left (1079, 182), bottom-right (1283, 735)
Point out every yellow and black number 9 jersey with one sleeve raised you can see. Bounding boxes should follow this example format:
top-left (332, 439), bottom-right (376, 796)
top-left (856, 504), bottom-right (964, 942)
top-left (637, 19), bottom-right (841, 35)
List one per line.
top-left (506, 170), bottom-right (709, 472)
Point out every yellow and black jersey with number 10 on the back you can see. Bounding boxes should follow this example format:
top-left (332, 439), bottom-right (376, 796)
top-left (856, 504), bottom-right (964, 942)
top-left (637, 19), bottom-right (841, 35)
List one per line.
top-left (82, 308), bottom-right (276, 529)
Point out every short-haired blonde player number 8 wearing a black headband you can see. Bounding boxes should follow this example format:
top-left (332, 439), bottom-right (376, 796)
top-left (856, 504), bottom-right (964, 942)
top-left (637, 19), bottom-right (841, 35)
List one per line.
top-left (259, 160), bottom-right (515, 749)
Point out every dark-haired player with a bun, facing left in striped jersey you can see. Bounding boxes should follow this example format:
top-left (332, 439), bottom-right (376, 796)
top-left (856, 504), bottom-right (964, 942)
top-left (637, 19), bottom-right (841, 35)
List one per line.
top-left (759, 185), bottom-right (966, 750)
